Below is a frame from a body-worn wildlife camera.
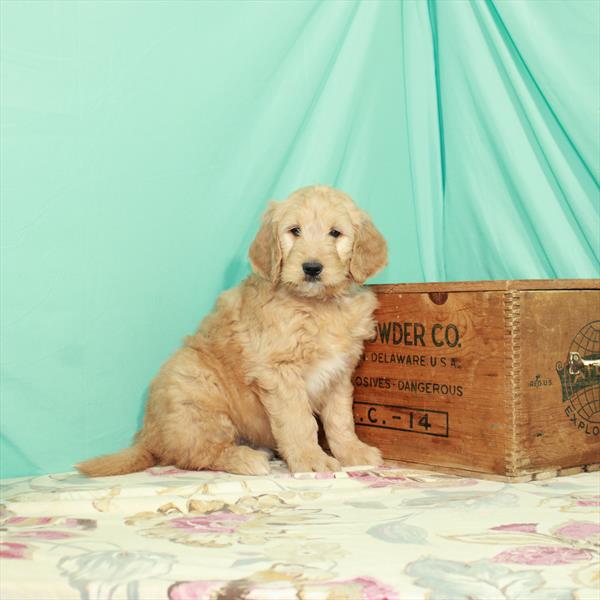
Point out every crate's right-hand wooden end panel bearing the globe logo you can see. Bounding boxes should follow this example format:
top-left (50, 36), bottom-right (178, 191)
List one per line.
top-left (519, 291), bottom-right (600, 472)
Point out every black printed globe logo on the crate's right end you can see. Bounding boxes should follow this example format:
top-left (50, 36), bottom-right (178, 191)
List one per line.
top-left (556, 321), bottom-right (600, 435)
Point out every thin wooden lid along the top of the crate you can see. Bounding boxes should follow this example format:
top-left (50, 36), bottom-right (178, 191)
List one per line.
top-left (369, 279), bottom-right (600, 294)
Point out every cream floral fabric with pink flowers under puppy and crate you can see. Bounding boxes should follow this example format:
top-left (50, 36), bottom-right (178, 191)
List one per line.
top-left (0, 463), bottom-right (600, 600)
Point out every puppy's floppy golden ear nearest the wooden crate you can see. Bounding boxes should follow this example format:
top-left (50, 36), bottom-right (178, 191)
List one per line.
top-left (350, 210), bottom-right (387, 283)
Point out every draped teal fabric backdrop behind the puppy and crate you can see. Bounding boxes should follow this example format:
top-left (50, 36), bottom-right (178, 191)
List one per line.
top-left (0, 0), bottom-right (600, 477)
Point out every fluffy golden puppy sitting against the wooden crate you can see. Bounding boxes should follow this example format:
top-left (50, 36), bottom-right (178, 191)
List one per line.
top-left (77, 186), bottom-right (387, 476)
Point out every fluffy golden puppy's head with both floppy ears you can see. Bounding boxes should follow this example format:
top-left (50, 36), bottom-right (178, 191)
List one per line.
top-left (249, 186), bottom-right (387, 297)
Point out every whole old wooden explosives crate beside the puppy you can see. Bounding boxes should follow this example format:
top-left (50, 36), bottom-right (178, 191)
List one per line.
top-left (353, 279), bottom-right (600, 481)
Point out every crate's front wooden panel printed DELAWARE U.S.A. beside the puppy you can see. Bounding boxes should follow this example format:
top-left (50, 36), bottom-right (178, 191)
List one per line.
top-left (353, 292), bottom-right (511, 475)
